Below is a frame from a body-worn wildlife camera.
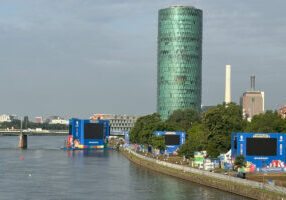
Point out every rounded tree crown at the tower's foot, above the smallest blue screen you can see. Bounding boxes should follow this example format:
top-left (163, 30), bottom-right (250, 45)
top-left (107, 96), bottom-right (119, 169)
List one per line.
top-left (166, 108), bottom-right (201, 131)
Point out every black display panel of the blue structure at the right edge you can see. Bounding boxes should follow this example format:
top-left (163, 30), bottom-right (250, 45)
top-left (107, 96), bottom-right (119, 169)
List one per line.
top-left (246, 138), bottom-right (277, 156)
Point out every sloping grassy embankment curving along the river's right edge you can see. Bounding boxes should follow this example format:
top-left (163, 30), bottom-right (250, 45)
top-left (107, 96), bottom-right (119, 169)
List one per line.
top-left (120, 148), bottom-right (286, 200)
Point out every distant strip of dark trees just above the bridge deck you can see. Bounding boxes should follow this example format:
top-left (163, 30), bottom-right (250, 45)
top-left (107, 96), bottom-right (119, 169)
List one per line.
top-left (0, 118), bottom-right (68, 130)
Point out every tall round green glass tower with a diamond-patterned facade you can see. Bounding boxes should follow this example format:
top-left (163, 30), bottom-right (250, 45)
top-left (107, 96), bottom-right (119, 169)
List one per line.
top-left (157, 6), bottom-right (203, 120)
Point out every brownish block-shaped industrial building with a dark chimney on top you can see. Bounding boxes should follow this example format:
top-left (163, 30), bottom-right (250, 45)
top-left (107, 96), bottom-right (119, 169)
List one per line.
top-left (240, 76), bottom-right (264, 121)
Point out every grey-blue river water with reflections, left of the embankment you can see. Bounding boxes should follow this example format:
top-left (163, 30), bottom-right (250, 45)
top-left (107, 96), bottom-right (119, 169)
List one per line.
top-left (0, 136), bottom-right (247, 200)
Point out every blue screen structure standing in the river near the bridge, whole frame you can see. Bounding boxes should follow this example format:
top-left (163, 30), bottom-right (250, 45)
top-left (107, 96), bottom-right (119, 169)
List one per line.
top-left (68, 119), bottom-right (109, 149)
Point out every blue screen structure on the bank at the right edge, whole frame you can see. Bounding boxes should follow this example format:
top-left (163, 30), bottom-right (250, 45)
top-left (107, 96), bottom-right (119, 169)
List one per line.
top-left (231, 133), bottom-right (286, 172)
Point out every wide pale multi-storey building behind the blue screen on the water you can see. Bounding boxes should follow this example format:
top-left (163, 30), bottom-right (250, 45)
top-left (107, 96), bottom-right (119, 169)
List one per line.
top-left (90, 114), bottom-right (138, 135)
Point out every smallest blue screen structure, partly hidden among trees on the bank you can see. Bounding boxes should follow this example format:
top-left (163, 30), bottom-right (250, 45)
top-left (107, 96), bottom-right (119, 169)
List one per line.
top-left (154, 131), bottom-right (186, 153)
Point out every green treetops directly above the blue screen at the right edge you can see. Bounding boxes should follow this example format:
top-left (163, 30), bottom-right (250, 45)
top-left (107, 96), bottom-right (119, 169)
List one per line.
top-left (245, 110), bottom-right (286, 133)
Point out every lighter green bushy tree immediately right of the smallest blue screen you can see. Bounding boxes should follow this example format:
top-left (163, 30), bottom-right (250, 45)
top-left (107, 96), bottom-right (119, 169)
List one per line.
top-left (178, 123), bottom-right (208, 158)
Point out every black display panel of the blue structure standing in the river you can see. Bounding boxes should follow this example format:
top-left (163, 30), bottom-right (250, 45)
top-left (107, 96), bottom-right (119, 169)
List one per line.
top-left (84, 123), bottom-right (103, 139)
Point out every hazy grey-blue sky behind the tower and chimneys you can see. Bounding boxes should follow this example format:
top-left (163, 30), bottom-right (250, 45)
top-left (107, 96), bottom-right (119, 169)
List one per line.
top-left (0, 0), bottom-right (286, 118)
